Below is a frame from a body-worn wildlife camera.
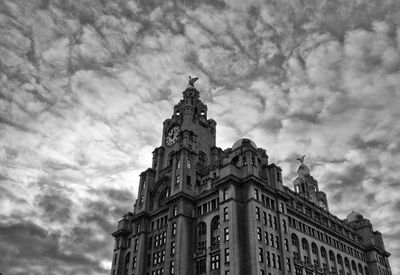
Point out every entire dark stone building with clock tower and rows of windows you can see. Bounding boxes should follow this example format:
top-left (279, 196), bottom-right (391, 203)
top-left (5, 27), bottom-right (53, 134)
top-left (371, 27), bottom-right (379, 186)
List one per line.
top-left (111, 78), bottom-right (391, 275)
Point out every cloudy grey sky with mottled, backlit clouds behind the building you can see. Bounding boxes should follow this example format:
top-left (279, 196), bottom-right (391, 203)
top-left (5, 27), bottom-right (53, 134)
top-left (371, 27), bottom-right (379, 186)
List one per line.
top-left (0, 0), bottom-right (400, 275)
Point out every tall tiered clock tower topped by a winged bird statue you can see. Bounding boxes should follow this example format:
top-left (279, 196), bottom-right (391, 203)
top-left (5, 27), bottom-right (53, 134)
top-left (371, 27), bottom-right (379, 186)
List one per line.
top-left (153, 78), bottom-right (218, 198)
